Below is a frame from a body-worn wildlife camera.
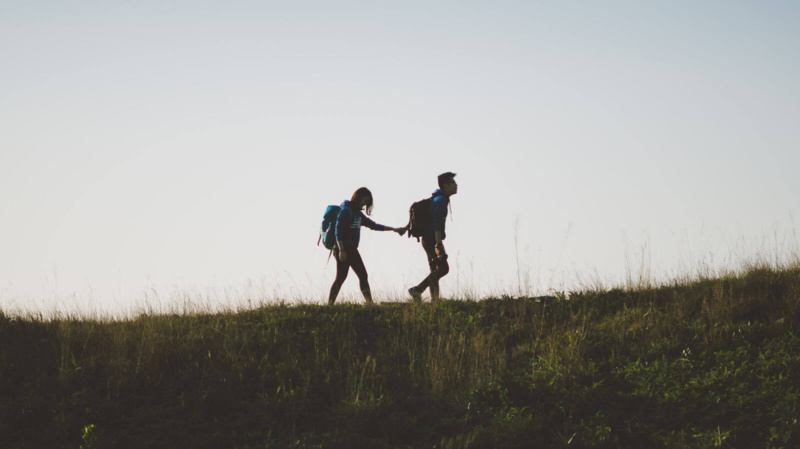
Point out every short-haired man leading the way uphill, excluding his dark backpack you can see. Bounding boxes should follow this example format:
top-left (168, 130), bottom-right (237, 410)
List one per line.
top-left (408, 172), bottom-right (458, 302)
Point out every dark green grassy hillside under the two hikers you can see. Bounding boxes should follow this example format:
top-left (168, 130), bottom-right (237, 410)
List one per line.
top-left (0, 267), bottom-right (800, 449)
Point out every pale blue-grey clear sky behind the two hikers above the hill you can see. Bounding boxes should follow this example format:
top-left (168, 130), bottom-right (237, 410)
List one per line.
top-left (0, 0), bottom-right (800, 314)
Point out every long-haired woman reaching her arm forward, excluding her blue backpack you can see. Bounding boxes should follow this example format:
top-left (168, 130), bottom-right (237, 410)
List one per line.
top-left (328, 187), bottom-right (405, 305)
